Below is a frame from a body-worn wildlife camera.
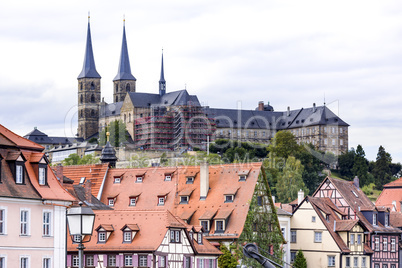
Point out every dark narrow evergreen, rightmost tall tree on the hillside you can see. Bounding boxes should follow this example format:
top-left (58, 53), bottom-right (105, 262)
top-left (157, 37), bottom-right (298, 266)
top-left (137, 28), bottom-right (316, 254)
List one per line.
top-left (373, 146), bottom-right (392, 190)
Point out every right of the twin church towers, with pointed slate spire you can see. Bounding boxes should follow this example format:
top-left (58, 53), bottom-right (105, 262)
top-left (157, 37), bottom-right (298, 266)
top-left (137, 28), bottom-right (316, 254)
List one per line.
top-left (113, 20), bottom-right (137, 102)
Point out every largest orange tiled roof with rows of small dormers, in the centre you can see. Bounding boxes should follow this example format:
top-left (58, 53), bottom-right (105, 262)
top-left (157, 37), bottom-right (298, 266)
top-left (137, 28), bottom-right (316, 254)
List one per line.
top-left (98, 163), bottom-right (261, 239)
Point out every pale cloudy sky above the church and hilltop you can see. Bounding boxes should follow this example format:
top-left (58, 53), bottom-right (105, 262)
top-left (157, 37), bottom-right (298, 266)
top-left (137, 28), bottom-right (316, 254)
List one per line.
top-left (0, 0), bottom-right (402, 162)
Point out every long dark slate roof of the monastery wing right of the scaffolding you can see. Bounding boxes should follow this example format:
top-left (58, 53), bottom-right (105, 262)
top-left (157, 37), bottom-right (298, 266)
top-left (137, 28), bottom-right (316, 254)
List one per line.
top-left (204, 106), bottom-right (349, 130)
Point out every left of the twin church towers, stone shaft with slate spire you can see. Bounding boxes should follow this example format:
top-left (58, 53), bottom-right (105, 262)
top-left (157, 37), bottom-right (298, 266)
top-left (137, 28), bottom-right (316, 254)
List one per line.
top-left (77, 16), bottom-right (101, 139)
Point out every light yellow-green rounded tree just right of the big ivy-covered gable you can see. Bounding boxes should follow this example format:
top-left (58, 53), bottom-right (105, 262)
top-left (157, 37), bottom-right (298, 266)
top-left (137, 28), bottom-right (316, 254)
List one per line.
top-left (276, 156), bottom-right (309, 203)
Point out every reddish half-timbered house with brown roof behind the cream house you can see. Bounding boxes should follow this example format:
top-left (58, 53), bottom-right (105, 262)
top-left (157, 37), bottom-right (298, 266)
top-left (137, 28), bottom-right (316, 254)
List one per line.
top-left (313, 177), bottom-right (401, 268)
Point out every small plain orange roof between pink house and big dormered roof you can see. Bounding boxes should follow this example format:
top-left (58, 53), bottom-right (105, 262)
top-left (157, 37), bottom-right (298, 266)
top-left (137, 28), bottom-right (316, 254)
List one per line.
top-left (54, 163), bottom-right (109, 197)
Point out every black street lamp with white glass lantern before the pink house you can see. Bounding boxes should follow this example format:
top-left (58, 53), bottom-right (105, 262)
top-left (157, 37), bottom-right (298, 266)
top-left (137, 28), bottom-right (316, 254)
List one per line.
top-left (67, 202), bottom-right (95, 268)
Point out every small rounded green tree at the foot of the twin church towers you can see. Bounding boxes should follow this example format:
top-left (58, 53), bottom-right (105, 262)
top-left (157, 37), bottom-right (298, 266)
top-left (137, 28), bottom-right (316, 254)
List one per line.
top-left (99, 120), bottom-right (128, 147)
